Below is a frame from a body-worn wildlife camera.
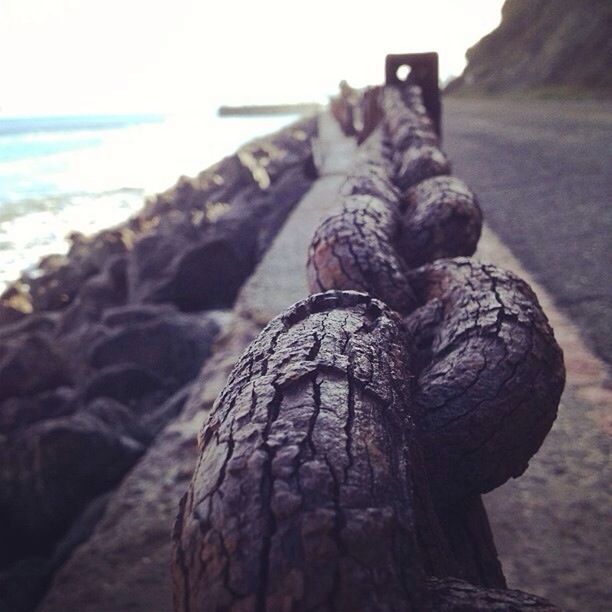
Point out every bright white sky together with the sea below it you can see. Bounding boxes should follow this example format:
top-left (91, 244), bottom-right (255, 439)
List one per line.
top-left (0, 0), bottom-right (502, 289)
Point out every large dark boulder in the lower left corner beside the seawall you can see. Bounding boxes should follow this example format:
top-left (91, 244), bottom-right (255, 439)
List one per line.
top-left (0, 399), bottom-right (144, 567)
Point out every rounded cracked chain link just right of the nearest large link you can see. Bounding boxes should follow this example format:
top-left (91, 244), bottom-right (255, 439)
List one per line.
top-left (405, 258), bottom-right (565, 503)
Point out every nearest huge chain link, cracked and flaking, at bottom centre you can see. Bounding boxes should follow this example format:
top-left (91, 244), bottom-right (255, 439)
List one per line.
top-left (174, 292), bottom-right (445, 612)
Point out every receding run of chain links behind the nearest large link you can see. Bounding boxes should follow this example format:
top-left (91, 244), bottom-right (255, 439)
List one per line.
top-left (307, 87), bottom-right (564, 502)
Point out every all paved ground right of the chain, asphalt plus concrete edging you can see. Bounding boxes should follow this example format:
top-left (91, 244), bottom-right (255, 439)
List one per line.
top-left (444, 99), bottom-right (612, 612)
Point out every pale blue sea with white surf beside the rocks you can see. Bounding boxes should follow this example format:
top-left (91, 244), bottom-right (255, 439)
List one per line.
top-left (0, 109), bottom-right (295, 290)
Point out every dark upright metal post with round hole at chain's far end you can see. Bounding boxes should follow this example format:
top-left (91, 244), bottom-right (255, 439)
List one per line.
top-left (385, 51), bottom-right (442, 138)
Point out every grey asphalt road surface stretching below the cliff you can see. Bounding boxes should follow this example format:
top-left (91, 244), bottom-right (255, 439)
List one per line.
top-left (443, 98), bottom-right (612, 364)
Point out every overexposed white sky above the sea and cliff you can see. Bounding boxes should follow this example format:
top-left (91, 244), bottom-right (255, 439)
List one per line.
top-left (0, 0), bottom-right (503, 116)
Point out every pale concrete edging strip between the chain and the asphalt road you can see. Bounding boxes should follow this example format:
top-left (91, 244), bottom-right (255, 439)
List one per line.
top-left (476, 227), bottom-right (612, 612)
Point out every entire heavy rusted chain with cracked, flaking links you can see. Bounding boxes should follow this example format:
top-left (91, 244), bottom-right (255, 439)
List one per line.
top-left (173, 88), bottom-right (564, 612)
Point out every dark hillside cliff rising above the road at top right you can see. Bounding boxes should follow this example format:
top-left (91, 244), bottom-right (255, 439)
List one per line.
top-left (446, 0), bottom-right (612, 96)
